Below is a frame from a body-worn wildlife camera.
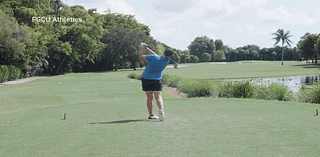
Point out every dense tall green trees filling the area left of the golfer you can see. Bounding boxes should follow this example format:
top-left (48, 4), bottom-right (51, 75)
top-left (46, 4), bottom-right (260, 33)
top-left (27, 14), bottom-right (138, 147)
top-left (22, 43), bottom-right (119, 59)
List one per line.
top-left (0, 0), bottom-right (161, 76)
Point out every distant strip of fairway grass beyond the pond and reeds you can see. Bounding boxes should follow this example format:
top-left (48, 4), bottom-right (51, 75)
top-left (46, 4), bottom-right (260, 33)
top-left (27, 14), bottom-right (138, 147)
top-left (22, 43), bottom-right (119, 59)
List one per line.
top-left (164, 61), bottom-right (320, 80)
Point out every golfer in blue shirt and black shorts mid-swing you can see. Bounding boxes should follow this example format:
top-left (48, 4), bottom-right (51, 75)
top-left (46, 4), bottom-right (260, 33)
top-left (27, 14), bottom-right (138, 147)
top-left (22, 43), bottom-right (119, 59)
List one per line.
top-left (139, 43), bottom-right (173, 121)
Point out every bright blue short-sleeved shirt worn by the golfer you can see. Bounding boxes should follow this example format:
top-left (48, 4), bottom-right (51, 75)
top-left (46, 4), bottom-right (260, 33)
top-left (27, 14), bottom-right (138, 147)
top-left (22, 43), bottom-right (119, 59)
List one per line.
top-left (142, 54), bottom-right (170, 80)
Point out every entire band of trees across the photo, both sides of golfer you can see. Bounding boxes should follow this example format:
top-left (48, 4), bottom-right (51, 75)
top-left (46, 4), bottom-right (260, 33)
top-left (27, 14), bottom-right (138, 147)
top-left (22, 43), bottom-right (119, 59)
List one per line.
top-left (0, 0), bottom-right (320, 76)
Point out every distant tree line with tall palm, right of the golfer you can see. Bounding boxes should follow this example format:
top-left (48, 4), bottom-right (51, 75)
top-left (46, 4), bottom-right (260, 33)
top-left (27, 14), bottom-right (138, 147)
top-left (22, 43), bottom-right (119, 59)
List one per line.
top-left (188, 29), bottom-right (320, 64)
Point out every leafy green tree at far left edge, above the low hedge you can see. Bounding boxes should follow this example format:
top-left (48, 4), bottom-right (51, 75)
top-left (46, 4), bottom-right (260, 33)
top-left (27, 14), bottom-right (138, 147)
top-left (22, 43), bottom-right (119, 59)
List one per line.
top-left (0, 10), bottom-right (37, 73)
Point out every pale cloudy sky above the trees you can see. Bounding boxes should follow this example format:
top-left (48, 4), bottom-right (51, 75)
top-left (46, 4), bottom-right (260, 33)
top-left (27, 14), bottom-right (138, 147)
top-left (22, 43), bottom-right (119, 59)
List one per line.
top-left (62, 0), bottom-right (320, 50)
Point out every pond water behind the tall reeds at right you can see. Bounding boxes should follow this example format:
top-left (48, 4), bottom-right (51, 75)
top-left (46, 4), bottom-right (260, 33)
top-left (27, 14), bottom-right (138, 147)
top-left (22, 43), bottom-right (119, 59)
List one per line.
top-left (227, 75), bottom-right (320, 93)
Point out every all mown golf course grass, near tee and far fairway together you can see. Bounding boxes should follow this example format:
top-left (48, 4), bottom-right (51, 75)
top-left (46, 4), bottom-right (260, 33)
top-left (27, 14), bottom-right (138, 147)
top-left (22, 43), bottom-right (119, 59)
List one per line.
top-left (0, 61), bottom-right (320, 157)
